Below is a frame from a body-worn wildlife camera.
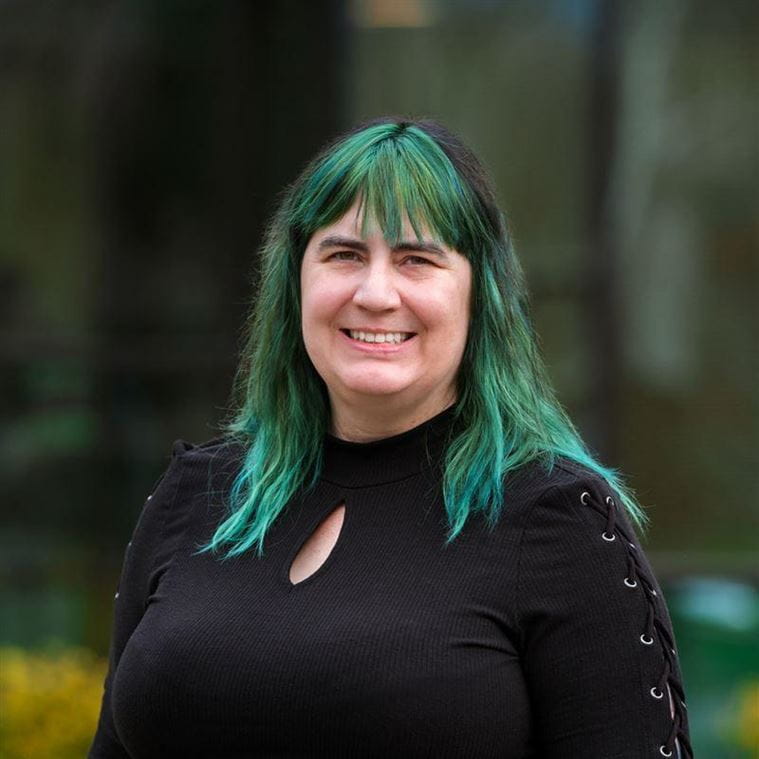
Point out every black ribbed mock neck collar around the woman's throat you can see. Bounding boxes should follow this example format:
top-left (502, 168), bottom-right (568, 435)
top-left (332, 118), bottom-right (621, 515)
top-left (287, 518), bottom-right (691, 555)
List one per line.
top-left (322, 404), bottom-right (456, 488)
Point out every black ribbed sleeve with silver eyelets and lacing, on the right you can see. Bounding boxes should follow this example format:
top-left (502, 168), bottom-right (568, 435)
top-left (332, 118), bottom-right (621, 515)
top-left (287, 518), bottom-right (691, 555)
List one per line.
top-left (517, 474), bottom-right (693, 759)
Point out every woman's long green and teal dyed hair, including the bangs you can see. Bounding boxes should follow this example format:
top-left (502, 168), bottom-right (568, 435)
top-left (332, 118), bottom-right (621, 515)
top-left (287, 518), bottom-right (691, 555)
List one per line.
top-left (200, 119), bottom-right (647, 558)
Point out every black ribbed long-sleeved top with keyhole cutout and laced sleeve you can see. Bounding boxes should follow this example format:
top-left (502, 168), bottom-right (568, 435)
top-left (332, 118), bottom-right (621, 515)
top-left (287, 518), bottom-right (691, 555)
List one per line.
top-left (89, 408), bottom-right (692, 759)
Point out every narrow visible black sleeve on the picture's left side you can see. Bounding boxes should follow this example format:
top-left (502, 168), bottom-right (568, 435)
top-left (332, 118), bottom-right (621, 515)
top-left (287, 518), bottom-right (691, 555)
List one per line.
top-left (88, 440), bottom-right (193, 759)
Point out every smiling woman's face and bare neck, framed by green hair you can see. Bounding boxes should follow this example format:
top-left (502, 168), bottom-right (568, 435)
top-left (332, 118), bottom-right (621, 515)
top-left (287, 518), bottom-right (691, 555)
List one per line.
top-left (301, 201), bottom-right (471, 441)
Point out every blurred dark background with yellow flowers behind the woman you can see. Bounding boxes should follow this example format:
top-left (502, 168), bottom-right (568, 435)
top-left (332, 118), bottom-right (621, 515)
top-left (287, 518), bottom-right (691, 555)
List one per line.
top-left (0, 0), bottom-right (759, 759)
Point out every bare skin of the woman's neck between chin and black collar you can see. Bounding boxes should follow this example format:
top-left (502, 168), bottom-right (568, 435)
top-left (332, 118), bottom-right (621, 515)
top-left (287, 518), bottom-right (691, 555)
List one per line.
top-left (330, 396), bottom-right (455, 443)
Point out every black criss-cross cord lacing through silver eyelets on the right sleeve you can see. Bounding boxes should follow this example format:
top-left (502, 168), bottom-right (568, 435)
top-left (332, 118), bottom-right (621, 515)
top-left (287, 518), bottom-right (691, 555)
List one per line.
top-left (580, 490), bottom-right (693, 759)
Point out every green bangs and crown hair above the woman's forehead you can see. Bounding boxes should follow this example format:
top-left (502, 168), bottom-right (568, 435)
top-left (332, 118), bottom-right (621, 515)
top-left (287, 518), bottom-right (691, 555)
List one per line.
top-left (291, 124), bottom-right (486, 257)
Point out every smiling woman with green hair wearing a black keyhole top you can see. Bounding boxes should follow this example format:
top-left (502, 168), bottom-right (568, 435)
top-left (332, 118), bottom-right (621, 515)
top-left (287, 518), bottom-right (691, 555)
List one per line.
top-left (90, 119), bottom-right (692, 759)
